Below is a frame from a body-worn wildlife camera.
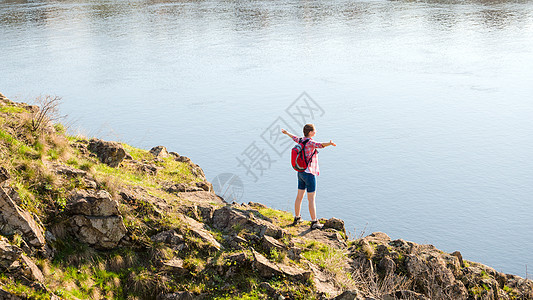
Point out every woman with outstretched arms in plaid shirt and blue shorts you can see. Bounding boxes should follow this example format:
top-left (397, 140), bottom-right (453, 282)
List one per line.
top-left (281, 124), bottom-right (337, 229)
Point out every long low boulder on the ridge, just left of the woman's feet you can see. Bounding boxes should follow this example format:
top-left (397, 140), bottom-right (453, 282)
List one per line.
top-left (212, 205), bottom-right (285, 239)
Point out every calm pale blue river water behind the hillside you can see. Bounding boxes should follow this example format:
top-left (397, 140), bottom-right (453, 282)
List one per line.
top-left (0, 0), bottom-right (533, 276)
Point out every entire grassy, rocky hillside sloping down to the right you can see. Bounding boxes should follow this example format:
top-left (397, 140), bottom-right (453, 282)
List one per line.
top-left (0, 94), bottom-right (533, 300)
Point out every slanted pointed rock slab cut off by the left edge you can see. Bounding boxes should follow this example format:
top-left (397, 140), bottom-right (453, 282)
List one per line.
top-left (0, 187), bottom-right (46, 249)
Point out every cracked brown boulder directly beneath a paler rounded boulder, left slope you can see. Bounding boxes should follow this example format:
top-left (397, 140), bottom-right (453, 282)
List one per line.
top-left (70, 215), bottom-right (127, 249)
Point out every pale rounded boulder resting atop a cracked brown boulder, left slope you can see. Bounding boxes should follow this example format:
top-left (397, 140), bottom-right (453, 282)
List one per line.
top-left (67, 190), bottom-right (120, 217)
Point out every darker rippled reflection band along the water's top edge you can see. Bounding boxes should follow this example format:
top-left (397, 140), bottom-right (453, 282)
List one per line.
top-left (0, 0), bottom-right (532, 31)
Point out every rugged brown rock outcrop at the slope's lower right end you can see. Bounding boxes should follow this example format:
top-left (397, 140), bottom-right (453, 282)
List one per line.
top-left (349, 232), bottom-right (533, 299)
